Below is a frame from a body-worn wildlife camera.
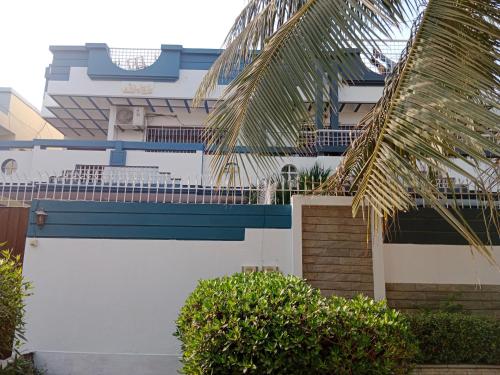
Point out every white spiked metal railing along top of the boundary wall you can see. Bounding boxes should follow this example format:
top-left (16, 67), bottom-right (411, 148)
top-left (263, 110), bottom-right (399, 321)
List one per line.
top-left (0, 170), bottom-right (500, 208)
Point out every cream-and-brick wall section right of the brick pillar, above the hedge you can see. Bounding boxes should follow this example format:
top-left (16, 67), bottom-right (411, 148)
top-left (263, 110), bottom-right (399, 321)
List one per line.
top-left (383, 244), bottom-right (500, 318)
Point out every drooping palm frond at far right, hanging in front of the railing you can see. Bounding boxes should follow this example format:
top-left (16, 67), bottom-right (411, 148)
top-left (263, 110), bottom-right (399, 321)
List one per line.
top-left (329, 0), bottom-right (500, 261)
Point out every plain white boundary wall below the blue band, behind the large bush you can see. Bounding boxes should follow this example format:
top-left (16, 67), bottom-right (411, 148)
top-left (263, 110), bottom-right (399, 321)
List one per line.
top-left (23, 229), bottom-right (292, 375)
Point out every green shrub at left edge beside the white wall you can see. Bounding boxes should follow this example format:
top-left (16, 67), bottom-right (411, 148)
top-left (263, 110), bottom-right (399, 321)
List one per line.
top-left (0, 251), bottom-right (30, 359)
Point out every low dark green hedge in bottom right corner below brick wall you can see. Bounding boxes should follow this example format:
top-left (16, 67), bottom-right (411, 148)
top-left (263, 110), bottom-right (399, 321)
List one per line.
top-left (409, 312), bottom-right (500, 365)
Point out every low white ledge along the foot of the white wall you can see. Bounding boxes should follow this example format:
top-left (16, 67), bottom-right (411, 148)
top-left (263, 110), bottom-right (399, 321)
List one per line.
top-left (34, 351), bottom-right (180, 375)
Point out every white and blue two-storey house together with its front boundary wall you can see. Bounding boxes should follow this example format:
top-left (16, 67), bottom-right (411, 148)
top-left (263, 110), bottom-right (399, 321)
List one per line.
top-left (0, 44), bottom-right (500, 375)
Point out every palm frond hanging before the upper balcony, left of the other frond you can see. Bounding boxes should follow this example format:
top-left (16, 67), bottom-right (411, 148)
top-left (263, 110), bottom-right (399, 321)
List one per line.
top-left (197, 0), bottom-right (415, 181)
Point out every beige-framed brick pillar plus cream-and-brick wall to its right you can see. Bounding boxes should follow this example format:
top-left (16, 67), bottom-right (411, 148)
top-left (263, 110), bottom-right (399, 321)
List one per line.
top-left (292, 196), bottom-right (500, 308)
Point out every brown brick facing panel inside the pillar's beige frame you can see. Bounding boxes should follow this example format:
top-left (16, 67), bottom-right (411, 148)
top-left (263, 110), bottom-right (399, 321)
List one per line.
top-left (302, 206), bottom-right (373, 298)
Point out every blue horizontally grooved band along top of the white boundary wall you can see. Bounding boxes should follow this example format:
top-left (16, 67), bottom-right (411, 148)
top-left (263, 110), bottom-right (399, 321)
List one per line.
top-left (28, 200), bottom-right (291, 241)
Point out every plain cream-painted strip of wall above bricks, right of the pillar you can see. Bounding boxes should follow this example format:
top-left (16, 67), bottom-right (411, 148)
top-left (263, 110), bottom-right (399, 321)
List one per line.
top-left (383, 244), bottom-right (500, 285)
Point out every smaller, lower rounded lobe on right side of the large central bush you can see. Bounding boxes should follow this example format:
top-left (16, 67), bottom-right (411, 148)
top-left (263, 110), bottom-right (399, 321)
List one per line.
top-left (322, 295), bottom-right (417, 374)
